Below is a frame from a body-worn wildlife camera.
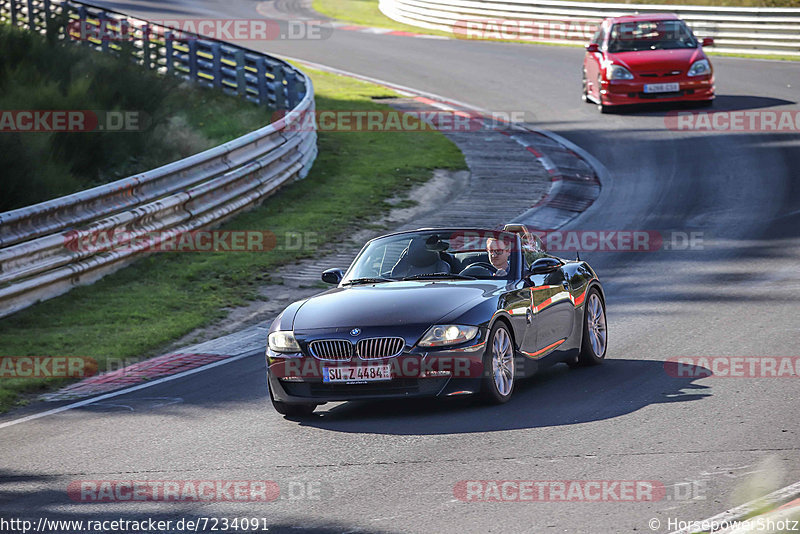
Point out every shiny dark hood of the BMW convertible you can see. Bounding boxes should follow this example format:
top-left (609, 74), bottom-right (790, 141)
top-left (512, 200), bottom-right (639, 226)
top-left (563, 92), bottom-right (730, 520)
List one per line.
top-left (293, 280), bottom-right (506, 332)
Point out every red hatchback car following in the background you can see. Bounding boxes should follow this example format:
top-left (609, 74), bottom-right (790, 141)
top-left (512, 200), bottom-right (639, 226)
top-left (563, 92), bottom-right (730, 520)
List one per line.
top-left (583, 13), bottom-right (714, 112)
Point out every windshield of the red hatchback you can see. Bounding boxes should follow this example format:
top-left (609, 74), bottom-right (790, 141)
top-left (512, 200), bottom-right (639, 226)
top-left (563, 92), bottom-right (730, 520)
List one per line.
top-left (608, 20), bottom-right (697, 53)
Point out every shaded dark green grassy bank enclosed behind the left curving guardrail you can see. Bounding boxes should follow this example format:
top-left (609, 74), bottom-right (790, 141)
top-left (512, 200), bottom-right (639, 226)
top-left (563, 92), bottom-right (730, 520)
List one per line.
top-left (0, 25), bottom-right (271, 211)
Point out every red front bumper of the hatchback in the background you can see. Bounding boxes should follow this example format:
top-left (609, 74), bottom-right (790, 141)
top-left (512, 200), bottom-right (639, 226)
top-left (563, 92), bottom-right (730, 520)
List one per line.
top-left (600, 76), bottom-right (714, 106)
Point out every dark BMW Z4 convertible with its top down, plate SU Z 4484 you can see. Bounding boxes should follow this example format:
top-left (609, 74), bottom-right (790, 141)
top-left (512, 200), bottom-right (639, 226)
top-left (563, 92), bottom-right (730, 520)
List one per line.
top-left (266, 224), bottom-right (607, 416)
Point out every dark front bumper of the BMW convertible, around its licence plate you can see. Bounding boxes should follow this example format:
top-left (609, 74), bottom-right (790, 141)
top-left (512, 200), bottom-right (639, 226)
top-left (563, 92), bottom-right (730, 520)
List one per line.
top-left (267, 343), bottom-right (485, 404)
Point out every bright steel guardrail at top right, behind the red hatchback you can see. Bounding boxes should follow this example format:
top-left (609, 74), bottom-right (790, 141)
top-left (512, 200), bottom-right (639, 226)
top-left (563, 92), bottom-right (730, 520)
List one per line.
top-left (379, 0), bottom-right (800, 56)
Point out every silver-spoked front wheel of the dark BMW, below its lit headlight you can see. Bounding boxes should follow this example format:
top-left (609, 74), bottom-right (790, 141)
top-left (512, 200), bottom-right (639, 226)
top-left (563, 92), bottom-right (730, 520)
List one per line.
top-left (481, 321), bottom-right (516, 404)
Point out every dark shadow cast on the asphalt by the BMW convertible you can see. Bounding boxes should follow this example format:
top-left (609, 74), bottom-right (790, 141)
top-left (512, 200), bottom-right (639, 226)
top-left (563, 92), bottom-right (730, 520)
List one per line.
top-left (300, 360), bottom-right (710, 436)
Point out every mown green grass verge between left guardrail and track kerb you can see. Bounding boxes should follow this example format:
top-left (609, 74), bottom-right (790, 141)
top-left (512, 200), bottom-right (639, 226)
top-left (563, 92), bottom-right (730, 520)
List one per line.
top-left (0, 65), bottom-right (466, 411)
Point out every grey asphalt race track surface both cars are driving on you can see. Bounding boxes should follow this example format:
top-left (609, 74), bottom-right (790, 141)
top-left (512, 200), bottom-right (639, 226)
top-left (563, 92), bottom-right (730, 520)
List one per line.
top-left (0, 0), bottom-right (800, 532)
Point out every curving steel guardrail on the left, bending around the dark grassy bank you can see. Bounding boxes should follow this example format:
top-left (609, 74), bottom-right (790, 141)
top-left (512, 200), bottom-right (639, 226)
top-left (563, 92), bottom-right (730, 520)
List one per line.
top-left (0, 0), bottom-right (317, 317)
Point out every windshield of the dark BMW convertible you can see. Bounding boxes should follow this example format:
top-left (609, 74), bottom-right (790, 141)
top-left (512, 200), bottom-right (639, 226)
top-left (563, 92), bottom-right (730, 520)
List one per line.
top-left (342, 230), bottom-right (519, 285)
